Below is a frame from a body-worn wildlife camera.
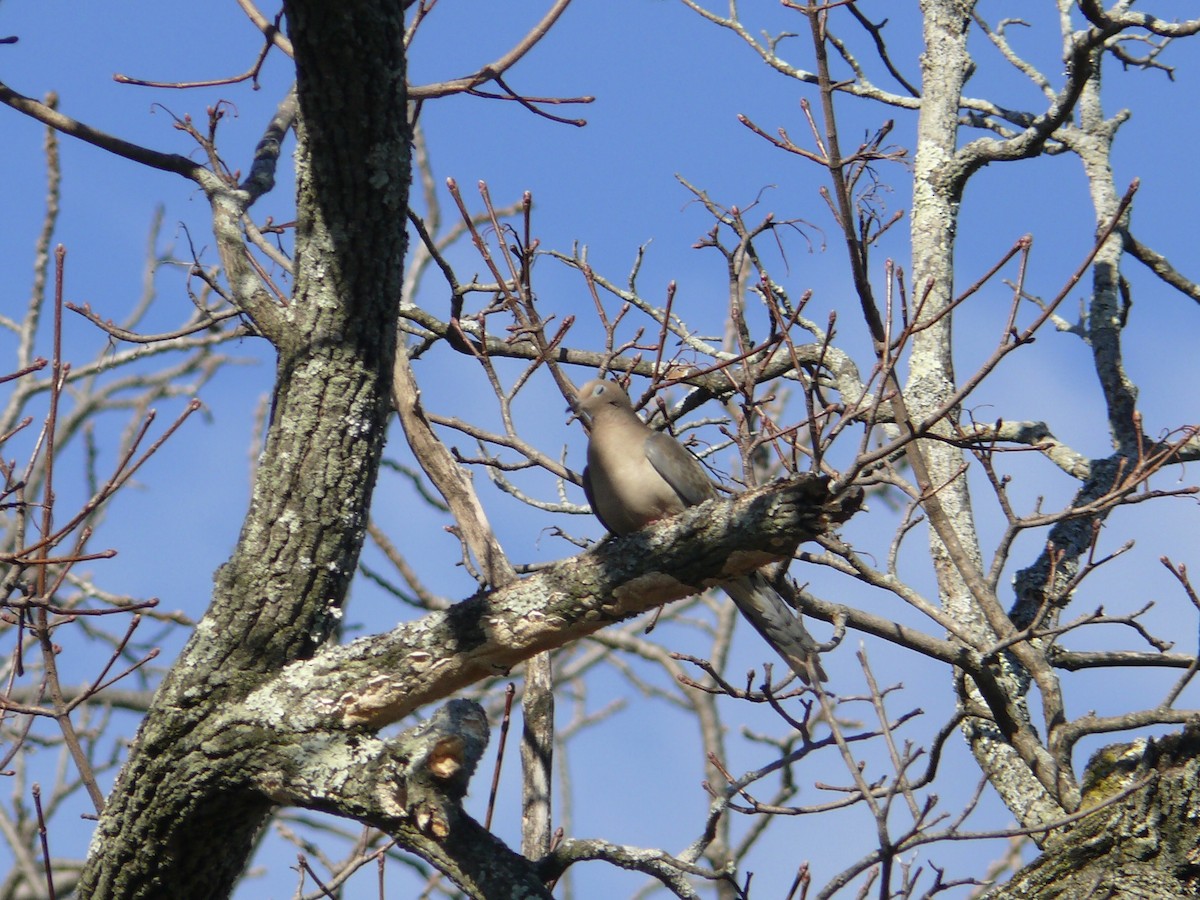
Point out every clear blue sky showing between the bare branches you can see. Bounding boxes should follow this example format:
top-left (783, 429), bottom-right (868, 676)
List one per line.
top-left (0, 0), bottom-right (1200, 898)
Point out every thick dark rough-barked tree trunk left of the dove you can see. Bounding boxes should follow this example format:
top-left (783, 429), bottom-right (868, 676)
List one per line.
top-left (80, 1), bottom-right (409, 900)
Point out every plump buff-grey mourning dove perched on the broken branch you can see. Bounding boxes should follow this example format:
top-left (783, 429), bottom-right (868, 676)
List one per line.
top-left (578, 378), bottom-right (826, 684)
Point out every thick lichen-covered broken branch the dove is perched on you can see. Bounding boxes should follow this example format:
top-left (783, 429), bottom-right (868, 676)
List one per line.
top-left (253, 476), bottom-right (860, 727)
